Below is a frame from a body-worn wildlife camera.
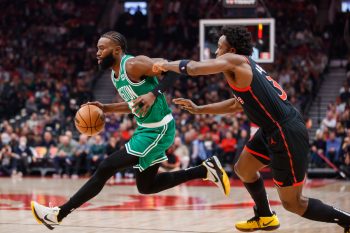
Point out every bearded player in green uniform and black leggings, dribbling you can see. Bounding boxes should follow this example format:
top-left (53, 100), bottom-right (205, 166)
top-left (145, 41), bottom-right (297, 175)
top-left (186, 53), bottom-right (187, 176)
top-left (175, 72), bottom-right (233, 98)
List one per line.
top-left (31, 31), bottom-right (230, 230)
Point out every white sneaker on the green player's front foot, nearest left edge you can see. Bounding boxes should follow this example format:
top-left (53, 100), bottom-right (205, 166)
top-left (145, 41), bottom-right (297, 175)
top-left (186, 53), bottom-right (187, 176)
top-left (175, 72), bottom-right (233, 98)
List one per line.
top-left (30, 201), bottom-right (60, 230)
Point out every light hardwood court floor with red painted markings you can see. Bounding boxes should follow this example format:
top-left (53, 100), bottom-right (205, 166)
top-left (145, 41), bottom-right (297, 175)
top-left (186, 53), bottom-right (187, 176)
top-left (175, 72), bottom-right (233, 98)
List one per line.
top-left (0, 178), bottom-right (350, 233)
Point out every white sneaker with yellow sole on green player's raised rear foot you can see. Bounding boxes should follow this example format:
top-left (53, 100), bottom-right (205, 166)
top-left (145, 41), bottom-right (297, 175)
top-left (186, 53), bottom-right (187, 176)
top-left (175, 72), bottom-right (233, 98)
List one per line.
top-left (203, 156), bottom-right (231, 196)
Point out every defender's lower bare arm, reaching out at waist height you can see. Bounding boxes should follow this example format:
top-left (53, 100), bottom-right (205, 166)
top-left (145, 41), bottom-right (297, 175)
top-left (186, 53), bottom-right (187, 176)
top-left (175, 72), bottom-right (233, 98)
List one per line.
top-left (173, 98), bottom-right (242, 114)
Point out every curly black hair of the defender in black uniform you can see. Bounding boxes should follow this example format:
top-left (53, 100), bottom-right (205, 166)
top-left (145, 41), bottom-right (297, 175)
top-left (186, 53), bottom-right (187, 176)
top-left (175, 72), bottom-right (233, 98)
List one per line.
top-left (221, 26), bottom-right (253, 56)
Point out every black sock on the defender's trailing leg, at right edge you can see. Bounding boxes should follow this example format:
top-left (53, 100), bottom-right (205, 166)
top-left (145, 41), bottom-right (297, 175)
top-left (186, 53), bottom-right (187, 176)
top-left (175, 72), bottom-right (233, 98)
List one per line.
top-left (302, 198), bottom-right (350, 226)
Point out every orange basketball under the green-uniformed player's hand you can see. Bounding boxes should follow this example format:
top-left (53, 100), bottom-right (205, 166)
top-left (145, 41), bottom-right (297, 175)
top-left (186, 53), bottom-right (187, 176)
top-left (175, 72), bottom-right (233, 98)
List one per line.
top-left (74, 104), bottom-right (105, 136)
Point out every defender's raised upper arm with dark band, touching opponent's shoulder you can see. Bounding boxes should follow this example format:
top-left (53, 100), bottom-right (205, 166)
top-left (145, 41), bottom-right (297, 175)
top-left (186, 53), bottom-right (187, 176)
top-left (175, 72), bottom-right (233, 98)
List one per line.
top-left (153, 53), bottom-right (244, 76)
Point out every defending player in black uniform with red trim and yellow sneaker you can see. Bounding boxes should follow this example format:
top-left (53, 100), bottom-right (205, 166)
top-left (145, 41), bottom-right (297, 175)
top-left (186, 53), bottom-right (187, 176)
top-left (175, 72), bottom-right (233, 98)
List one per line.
top-left (153, 26), bottom-right (350, 233)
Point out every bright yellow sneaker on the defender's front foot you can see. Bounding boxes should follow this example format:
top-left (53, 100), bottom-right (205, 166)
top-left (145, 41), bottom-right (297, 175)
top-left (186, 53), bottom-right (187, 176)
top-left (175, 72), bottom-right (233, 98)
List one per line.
top-left (235, 208), bottom-right (280, 232)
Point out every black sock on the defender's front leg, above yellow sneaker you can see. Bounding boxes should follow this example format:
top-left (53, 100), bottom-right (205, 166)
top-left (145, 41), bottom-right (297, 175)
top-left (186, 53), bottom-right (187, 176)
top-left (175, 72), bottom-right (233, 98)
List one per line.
top-left (243, 176), bottom-right (273, 217)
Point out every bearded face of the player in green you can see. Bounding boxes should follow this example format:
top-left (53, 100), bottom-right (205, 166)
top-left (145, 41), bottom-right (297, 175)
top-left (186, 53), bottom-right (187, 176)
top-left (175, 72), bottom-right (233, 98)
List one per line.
top-left (96, 37), bottom-right (120, 70)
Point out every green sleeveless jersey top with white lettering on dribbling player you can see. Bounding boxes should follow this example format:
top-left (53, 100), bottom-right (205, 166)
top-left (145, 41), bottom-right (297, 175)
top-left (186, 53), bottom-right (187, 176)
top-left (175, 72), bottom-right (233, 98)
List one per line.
top-left (111, 55), bottom-right (171, 124)
